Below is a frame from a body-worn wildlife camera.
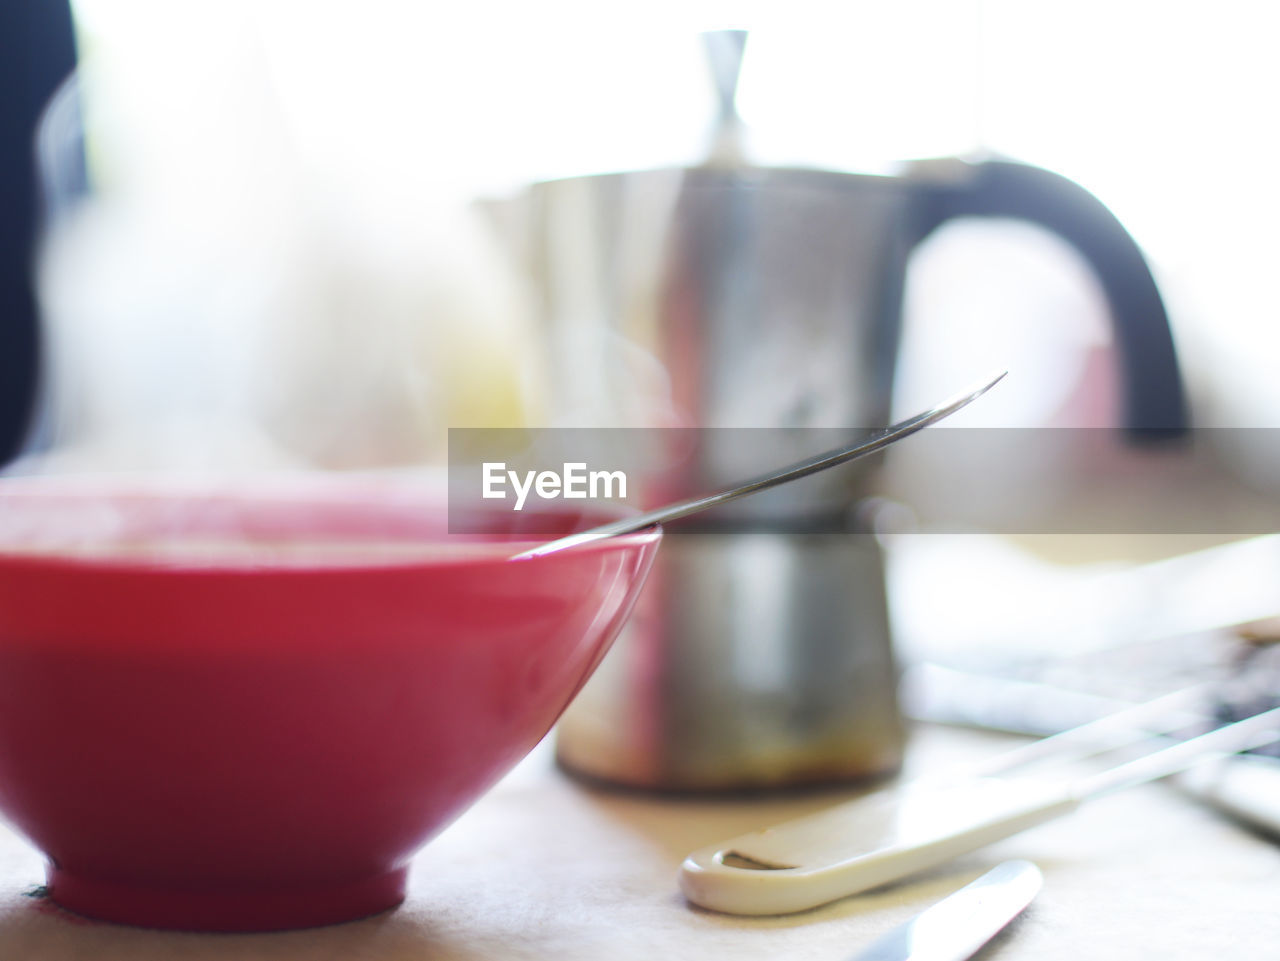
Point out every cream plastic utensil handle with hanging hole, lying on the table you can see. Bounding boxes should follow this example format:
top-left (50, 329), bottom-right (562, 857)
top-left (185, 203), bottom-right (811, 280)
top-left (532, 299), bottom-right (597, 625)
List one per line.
top-left (680, 778), bottom-right (1079, 915)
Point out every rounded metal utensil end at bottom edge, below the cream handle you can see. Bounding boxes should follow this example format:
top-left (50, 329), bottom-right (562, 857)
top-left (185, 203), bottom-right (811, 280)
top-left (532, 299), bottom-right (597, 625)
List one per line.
top-left (849, 861), bottom-right (1043, 961)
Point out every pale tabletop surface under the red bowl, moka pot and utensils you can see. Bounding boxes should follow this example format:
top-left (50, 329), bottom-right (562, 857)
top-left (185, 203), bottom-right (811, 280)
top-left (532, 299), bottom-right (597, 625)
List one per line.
top-left (0, 726), bottom-right (1280, 961)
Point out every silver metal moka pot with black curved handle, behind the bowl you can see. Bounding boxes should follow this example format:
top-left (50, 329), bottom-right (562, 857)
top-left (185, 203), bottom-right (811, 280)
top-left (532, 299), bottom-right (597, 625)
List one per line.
top-left (489, 32), bottom-right (1185, 790)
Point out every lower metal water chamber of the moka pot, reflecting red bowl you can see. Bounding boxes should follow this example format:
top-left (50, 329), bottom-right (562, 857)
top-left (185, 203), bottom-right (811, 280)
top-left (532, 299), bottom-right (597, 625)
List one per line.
top-left (557, 528), bottom-right (904, 791)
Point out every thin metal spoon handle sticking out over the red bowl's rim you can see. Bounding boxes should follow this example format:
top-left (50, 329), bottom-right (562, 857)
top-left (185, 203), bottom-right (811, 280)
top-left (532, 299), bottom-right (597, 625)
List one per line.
top-left (515, 371), bottom-right (1009, 558)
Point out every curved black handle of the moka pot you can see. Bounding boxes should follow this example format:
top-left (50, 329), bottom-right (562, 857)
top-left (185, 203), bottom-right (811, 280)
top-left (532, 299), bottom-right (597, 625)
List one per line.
top-left (918, 161), bottom-right (1187, 439)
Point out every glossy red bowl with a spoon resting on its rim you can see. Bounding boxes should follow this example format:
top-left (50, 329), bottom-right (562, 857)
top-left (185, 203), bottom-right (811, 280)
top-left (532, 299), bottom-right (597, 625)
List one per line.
top-left (0, 481), bottom-right (660, 930)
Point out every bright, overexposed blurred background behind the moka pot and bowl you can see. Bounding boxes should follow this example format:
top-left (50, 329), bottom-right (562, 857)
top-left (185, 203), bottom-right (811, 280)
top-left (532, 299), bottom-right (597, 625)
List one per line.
top-left (6, 0), bottom-right (1280, 475)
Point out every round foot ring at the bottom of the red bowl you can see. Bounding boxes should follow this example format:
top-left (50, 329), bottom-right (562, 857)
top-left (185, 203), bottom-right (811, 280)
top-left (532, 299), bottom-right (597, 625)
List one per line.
top-left (47, 866), bottom-right (408, 932)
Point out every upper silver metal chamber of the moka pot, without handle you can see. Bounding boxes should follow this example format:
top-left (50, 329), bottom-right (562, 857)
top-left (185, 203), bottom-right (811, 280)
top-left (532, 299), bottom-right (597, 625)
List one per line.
top-left (490, 168), bottom-right (911, 458)
